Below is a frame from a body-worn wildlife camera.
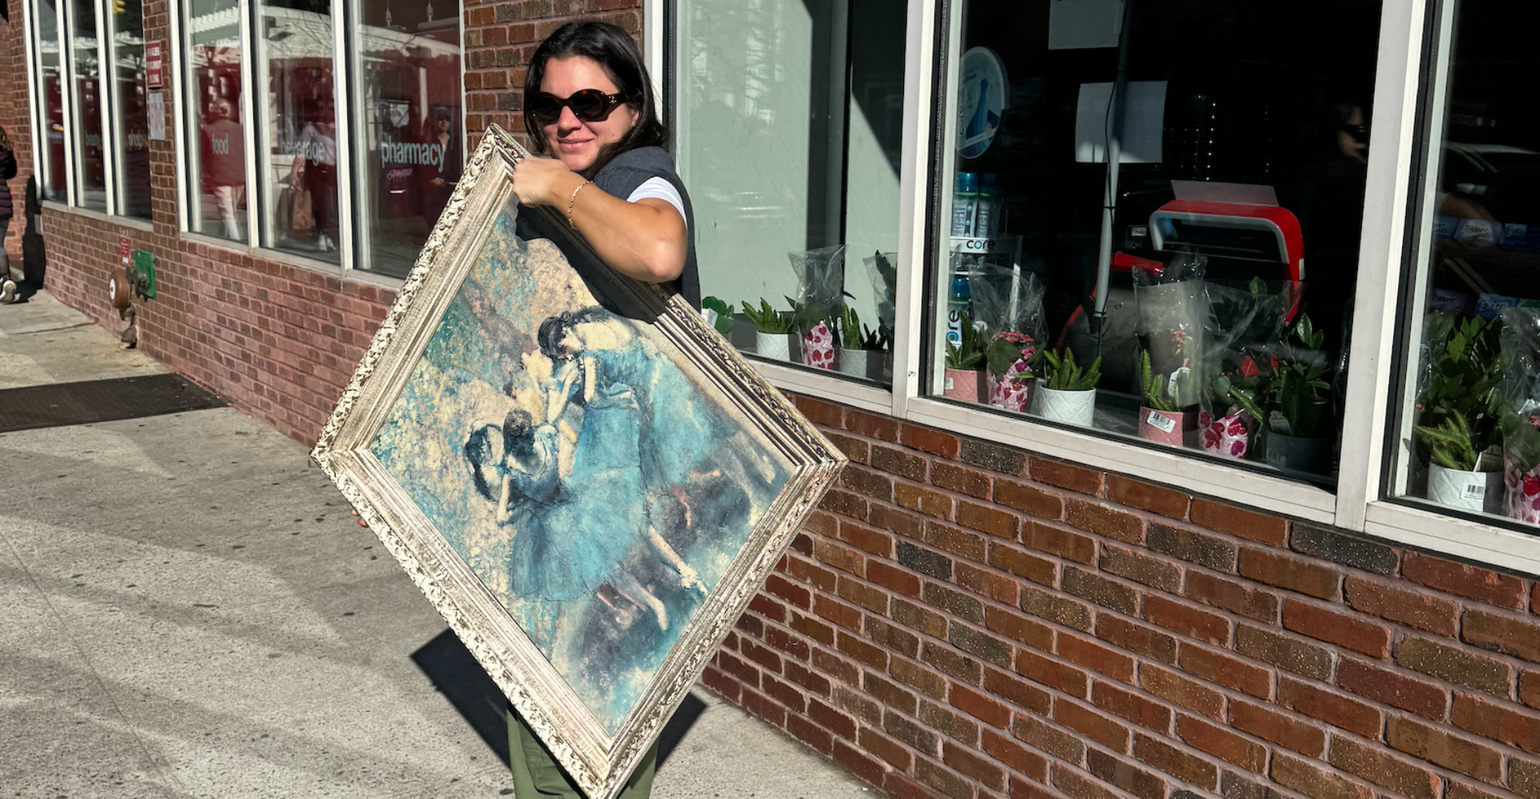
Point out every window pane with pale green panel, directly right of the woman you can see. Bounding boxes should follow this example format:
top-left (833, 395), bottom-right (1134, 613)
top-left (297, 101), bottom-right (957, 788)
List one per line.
top-left (675, 0), bottom-right (906, 382)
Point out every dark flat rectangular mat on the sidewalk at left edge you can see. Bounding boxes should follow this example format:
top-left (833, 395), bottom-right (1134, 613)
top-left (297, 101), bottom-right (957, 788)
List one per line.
top-left (0, 374), bottom-right (225, 433)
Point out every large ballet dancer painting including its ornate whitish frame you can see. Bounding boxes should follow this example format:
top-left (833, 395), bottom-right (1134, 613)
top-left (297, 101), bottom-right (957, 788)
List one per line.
top-left (311, 128), bottom-right (845, 799)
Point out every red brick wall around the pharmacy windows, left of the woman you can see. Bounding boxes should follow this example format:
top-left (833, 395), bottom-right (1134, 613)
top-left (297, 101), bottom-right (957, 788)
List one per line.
top-left (0, 0), bottom-right (641, 442)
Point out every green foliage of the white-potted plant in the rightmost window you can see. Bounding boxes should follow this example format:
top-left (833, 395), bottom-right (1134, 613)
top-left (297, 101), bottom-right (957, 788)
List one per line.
top-left (1414, 314), bottom-right (1503, 471)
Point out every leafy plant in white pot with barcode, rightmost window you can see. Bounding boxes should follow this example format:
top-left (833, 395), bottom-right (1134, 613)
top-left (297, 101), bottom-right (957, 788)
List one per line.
top-left (1414, 314), bottom-right (1503, 513)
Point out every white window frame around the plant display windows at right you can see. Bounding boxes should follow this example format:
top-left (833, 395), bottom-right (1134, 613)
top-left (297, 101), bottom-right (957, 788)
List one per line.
top-left (668, 0), bottom-right (1540, 563)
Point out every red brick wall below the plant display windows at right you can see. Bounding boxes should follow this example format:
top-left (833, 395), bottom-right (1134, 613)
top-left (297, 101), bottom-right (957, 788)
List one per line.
top-left (705, 399), bottom-right (1540, 799)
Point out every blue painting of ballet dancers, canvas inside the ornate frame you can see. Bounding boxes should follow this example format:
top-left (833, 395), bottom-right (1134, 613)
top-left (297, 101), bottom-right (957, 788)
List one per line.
top-left (371, 203), bottom-right (792, 731)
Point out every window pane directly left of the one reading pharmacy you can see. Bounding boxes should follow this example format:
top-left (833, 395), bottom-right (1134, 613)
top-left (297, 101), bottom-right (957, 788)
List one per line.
top-left (257, 0), bottom-right (342, 263)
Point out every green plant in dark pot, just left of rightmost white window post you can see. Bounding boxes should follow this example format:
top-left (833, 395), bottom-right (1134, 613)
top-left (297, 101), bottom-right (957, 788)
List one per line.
top-left (1264, 314), bottom-right (1335, 474)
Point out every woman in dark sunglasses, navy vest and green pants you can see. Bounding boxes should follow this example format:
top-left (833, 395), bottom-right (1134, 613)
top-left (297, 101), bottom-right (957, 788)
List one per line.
top-left (508, 22), bottom-right (701, 799)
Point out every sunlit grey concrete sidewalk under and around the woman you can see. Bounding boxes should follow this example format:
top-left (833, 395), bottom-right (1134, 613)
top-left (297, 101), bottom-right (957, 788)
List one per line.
top-left (0, 294), bottom-right (872, 799)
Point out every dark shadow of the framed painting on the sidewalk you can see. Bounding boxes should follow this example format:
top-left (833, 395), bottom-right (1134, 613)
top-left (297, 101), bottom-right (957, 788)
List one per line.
top-left (411, 630), bottom-right (705, 767)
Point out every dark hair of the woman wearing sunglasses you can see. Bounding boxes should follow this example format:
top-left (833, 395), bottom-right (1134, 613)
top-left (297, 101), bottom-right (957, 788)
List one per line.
top-left (524, 22), bottom-right (668, 179)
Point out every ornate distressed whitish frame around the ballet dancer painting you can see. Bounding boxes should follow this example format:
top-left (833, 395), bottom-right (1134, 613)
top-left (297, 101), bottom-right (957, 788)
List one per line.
top-left (311, 126), bottom-right (845, 799)
